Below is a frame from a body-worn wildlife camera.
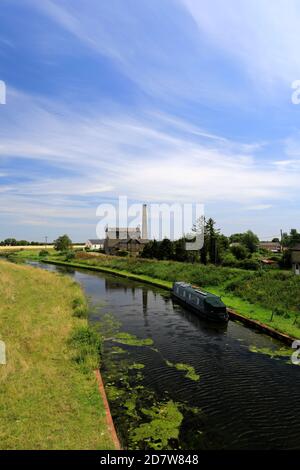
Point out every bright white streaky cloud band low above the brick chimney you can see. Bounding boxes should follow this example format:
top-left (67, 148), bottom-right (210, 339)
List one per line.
top-left (0, 87), bottom-right (298, 226)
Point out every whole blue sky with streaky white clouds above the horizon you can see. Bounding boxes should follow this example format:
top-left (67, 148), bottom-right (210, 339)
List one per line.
top-left (0, 0), bottom-right (300, 241)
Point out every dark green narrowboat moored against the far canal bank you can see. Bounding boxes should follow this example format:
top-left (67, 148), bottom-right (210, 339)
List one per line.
top-left (172, 282), bottom-right (229, 323)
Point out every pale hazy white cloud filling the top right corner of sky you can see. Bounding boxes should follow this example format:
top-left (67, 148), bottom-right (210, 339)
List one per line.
top-left (181, 0), bottom-right (300, 89)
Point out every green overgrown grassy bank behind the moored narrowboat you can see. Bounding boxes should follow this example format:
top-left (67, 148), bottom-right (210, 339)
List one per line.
top-left (50, 252), bottom-right (300, 338)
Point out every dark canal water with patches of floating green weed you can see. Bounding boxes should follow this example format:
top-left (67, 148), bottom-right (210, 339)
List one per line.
top-left (30, 265), bottom-right (300, 449)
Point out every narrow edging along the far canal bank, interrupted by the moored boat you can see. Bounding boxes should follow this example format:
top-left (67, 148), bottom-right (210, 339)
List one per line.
top-left (42, 259), bottom-right (296, 346)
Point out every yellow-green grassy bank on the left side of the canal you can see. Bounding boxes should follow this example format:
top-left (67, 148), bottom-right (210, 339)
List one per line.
top-left (0, 261), bottom-right (113, 449)
